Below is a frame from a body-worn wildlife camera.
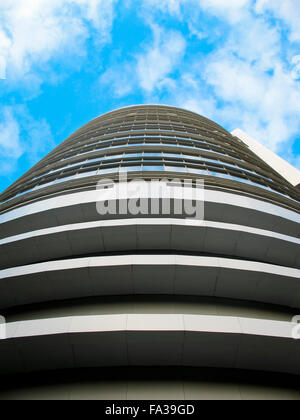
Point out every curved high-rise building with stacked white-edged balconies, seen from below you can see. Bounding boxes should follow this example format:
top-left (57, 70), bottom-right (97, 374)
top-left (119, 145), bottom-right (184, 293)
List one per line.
top-left (0, 105), bottom-right (300, 400)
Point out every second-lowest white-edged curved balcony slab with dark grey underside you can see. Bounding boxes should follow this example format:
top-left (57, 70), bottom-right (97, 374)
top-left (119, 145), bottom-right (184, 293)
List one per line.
top-left (0, 254), bottom-right (300, 309)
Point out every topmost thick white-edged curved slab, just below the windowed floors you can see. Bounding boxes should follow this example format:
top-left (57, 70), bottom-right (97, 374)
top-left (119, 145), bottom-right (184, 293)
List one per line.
top-left (0, 190), bottom-right (300, 239)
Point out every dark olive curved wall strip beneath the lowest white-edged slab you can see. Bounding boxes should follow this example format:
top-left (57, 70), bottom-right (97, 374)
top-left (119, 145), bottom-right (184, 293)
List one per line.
top-left (0, 366), bottom-right (300, 401)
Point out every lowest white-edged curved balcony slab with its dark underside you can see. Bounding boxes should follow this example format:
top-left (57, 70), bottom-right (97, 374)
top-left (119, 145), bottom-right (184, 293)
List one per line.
top-left (0, 314), bottom-right (300, 374)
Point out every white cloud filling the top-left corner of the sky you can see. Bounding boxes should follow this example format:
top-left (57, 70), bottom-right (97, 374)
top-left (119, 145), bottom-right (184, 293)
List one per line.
top-left (0, 0), bottom-right (115, 78)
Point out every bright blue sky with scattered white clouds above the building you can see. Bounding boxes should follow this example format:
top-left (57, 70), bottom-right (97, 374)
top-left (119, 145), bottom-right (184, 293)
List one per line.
top-left (0, 0), bottom-right (300, 190)
